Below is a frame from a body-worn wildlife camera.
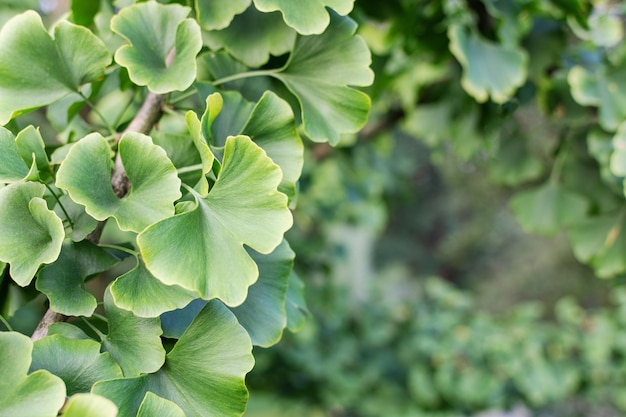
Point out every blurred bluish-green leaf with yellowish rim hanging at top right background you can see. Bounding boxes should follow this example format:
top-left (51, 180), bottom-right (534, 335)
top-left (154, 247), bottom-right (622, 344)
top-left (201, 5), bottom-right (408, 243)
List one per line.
top-left (448, 25), bottom-right (528, 103)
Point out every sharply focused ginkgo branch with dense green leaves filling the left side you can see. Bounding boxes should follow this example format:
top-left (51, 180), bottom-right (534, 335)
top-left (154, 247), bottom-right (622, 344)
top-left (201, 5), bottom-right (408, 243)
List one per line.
top-left (0, 0), bottom-right (373, 417)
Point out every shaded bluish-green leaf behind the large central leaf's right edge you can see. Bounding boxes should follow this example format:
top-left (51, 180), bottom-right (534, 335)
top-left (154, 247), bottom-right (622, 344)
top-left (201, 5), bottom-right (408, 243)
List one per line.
top-left (233, 241), bottom-right (295, 347)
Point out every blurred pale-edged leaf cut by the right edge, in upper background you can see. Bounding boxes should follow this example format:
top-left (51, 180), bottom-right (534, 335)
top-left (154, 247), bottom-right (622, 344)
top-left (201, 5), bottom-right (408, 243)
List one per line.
top-left (567, 66), bottom-right (626, 131)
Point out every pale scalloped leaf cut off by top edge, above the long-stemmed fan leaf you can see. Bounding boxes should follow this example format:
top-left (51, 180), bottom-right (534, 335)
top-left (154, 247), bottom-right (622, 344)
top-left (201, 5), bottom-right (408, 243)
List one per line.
top-left (254, 0), bottom-right (354, 35)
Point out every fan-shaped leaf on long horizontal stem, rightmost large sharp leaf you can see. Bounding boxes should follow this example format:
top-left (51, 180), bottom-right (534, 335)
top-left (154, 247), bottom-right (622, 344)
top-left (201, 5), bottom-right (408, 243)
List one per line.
top-left (269, 13), bottom-right (374, 145)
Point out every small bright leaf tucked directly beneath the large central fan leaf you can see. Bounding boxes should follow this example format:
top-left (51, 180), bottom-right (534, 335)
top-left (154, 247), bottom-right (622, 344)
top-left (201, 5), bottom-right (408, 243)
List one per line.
top-left (111, 255), bottom-right (199, 317)
